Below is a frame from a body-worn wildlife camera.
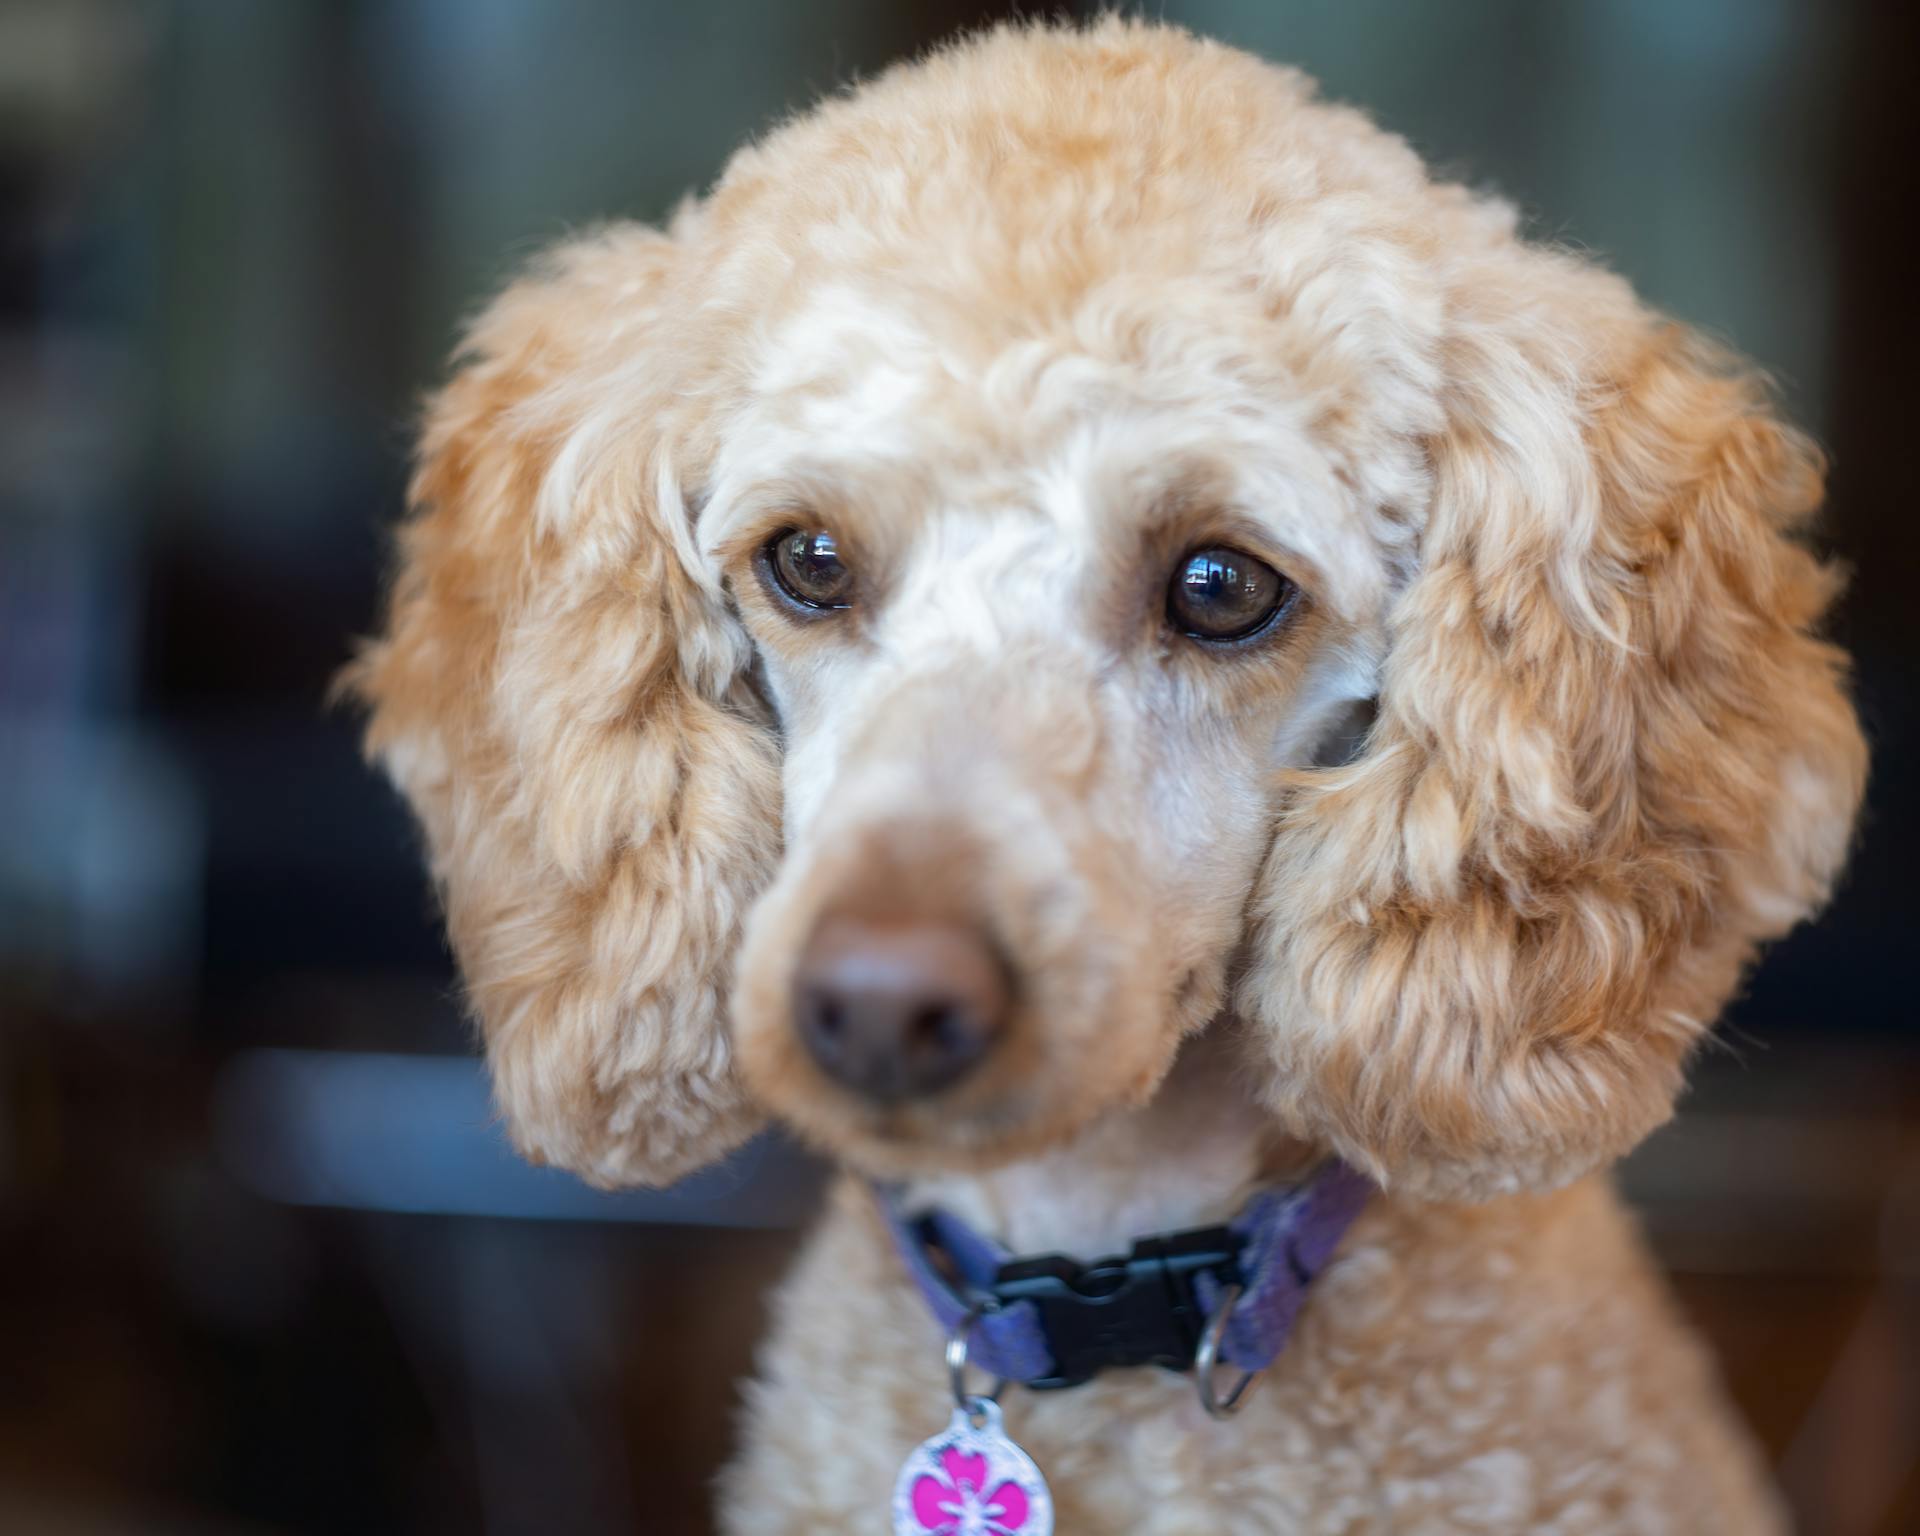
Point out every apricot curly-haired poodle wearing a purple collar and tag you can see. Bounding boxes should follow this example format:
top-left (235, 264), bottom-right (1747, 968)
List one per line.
top-left (348, 19), bottom-right (1866, 1536)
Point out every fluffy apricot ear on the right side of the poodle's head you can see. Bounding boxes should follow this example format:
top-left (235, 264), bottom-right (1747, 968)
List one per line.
top-left (1240, 248), bottom-right (1866, 1198)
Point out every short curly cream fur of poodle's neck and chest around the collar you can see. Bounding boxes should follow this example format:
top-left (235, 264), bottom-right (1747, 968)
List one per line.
top-left (724, 1054), bottom-right (1780, 1536)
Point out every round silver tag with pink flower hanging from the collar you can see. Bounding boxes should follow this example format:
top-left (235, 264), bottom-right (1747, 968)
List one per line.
top-left (893, 1398), bottom-right (1054, 1536)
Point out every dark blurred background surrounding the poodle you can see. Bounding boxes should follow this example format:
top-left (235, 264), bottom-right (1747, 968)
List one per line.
top-left (0, 0), bottom-right (1920, 1536)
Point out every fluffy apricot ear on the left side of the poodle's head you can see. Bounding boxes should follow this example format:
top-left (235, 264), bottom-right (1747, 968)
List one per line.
top-left (344, 227), bottom-right (780, 1185)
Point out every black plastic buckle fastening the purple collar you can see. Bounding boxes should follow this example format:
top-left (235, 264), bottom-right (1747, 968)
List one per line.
top-left (993, 1227), bottom-right (1246, 1392)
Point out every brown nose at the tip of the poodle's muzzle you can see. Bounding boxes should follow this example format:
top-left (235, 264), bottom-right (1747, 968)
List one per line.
top-left (793, 916), bottom-right (1008, 1102)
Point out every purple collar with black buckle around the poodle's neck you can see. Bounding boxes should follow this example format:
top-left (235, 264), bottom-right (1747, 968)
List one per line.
top-left (879, 1162), bottom-right (1373, 1392)
